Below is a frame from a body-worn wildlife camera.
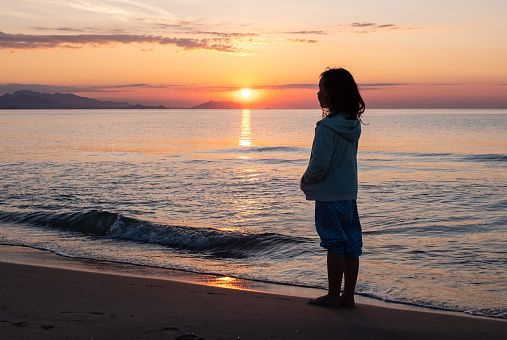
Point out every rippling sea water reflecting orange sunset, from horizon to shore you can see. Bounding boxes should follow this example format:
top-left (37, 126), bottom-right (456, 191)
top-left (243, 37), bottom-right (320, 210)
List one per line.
top-left (0, 110), bottom-right (507, 318)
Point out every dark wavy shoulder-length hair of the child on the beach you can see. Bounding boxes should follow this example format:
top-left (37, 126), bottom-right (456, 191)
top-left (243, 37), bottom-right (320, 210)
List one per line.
top-left (320, 67), bottom-right (365, 120)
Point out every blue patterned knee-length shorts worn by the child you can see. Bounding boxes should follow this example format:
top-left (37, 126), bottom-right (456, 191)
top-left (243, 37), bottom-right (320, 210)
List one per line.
top-left (315, 200), bottom-right (363, 259)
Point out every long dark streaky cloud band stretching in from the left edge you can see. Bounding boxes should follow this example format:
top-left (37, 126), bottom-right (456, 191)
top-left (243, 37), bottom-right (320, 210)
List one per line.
top-left (0, 32), bottom-right (239, 53)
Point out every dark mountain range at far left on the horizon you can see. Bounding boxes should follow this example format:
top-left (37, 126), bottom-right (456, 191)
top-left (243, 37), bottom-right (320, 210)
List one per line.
top-left (0, 90), bottom-right (166, 109)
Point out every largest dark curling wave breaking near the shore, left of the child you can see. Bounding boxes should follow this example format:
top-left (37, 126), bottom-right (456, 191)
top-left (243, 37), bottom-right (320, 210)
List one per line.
top-left (0, 210), bottom-right (311, 258)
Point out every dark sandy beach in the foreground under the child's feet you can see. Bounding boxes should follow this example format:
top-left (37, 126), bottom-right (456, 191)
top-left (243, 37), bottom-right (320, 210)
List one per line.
top-left (0, 248), bottom-right (507, 339)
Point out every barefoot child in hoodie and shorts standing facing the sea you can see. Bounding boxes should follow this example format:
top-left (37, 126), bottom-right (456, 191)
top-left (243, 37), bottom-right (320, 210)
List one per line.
top-left (301, 68), bottom-right (365, 307)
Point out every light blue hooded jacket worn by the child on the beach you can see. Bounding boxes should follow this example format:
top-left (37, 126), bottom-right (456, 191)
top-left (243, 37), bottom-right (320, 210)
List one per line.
top-left (301, 114), bottom-right (361, 201)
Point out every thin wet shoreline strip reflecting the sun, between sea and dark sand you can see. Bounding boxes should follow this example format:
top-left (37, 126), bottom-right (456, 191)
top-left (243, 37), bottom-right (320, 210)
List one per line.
top-left (0, 244), bottom-right (507, 321)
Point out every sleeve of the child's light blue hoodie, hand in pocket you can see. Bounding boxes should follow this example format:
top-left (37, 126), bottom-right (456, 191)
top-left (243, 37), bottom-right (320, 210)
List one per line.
top-left (303, 125), bottom-right (335, 184)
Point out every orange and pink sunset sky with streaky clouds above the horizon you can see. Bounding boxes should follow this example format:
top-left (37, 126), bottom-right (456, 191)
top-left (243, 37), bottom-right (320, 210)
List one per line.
top-left (0, 0), bottom-right (507, 109)
